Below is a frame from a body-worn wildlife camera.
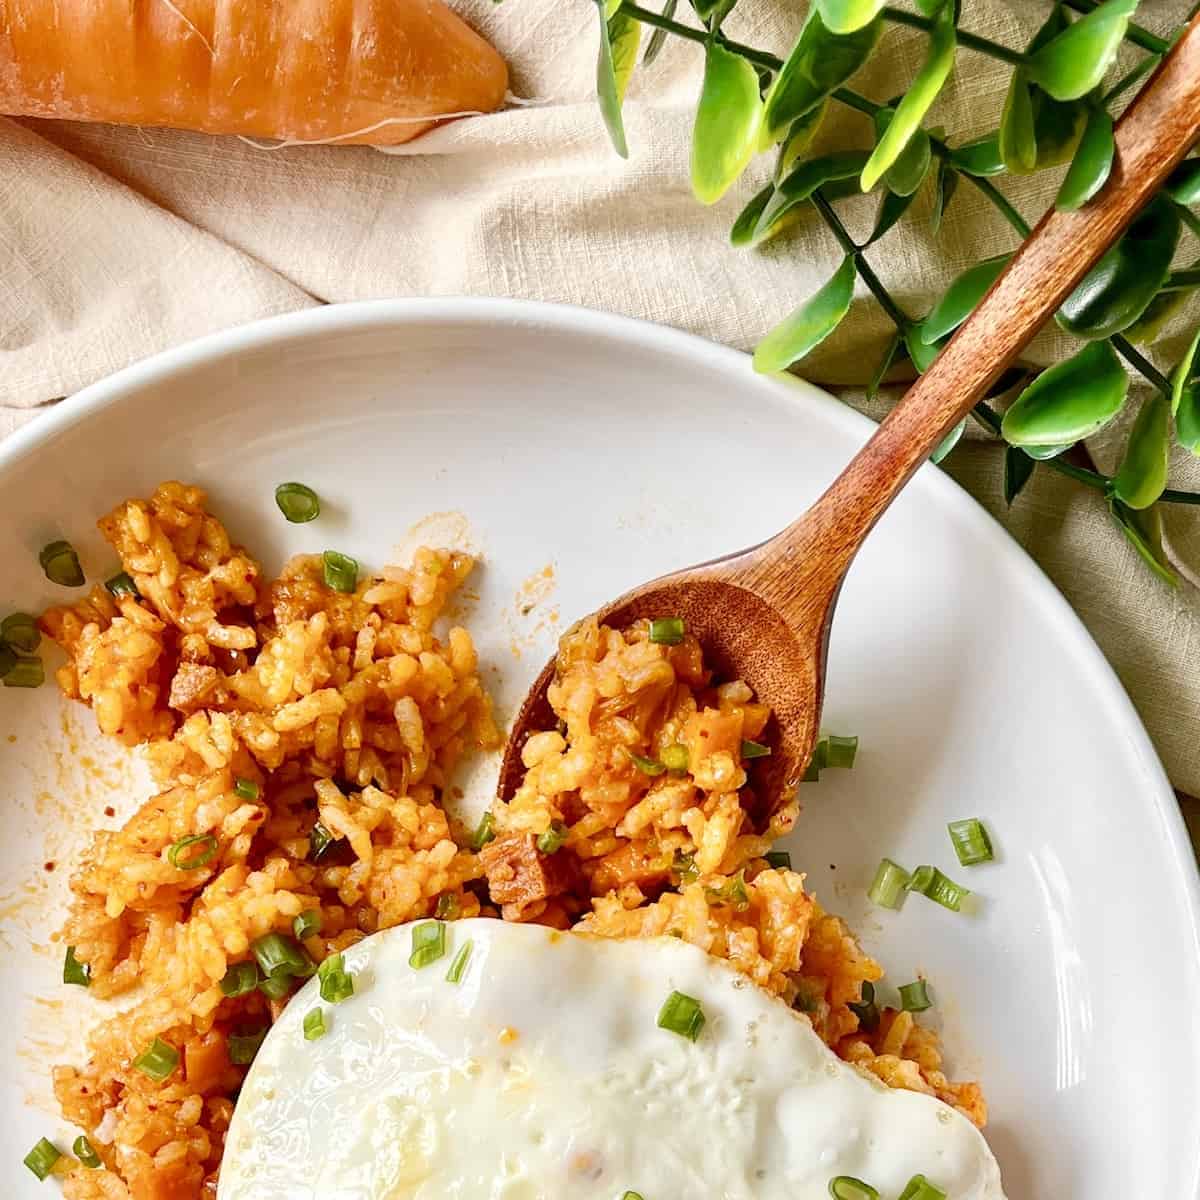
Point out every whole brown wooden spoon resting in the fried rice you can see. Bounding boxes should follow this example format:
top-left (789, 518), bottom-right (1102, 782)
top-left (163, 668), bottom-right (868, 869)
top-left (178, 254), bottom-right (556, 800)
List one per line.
top-left (498, 17), bottom-right (1200, 821)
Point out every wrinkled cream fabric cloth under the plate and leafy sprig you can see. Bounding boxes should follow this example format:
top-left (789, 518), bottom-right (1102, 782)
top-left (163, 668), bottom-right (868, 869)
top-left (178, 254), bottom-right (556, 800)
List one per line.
top-left (0, 0), bottom-right (1200, 793)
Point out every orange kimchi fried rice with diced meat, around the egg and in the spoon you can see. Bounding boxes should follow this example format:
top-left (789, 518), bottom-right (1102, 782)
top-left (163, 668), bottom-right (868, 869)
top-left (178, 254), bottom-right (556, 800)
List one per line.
top-left (32, 482), bottom-right (986, 1200)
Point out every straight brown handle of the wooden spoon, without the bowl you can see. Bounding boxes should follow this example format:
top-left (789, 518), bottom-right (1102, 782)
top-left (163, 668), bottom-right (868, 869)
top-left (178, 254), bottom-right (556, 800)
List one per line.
top-left (758, 17), bottom-right (1200, 585)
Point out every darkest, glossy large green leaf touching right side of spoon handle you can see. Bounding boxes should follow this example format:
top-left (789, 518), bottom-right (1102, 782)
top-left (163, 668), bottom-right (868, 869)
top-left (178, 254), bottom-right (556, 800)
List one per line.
top-left (1056, 194), bottom-right (1180, 338)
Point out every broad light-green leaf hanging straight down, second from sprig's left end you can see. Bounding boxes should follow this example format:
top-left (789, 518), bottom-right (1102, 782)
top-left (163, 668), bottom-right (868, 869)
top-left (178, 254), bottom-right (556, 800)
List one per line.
top-left (691, 42), bottom-right (762, 204)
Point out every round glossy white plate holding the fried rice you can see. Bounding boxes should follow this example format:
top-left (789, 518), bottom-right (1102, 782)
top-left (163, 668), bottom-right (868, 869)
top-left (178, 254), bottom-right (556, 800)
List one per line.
top-left (0, 300), bottom-right (1200, 1200)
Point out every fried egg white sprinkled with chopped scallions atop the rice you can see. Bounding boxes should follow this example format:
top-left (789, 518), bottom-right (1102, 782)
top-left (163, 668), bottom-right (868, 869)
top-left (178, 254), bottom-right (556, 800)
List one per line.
top-left (217, 919), bottom-right (1003, 1200)
